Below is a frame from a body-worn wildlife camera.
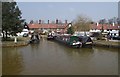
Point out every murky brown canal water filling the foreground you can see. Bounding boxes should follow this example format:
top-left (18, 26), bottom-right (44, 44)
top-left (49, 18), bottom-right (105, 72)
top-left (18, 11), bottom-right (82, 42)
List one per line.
top-left (2, 39), bottom-right (118, 75)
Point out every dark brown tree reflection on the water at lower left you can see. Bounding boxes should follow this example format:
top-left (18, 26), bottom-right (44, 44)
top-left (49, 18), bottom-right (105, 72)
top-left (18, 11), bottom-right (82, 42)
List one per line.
top-left (2, 48), bottom-right (23, 75)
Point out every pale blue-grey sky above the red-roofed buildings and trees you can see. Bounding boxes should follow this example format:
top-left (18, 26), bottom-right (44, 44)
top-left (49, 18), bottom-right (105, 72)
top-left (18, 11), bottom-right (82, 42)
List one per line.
top-left (18, 2), bottom-right (118, 22)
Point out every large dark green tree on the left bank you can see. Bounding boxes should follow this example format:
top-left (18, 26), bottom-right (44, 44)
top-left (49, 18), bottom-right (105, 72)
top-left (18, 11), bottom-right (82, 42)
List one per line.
top-left (2, 2), bottom-right (24, 38)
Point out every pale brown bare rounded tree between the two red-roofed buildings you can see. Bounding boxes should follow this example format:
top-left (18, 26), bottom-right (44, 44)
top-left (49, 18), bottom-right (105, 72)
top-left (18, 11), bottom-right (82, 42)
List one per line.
top-left (73, 15), bottom-right (92, 35)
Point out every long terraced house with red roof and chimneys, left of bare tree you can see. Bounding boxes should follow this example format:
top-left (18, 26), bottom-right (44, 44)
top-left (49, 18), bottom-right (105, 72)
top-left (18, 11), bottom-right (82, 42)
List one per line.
top-left (28, 20), bottom-right (69, 32)
